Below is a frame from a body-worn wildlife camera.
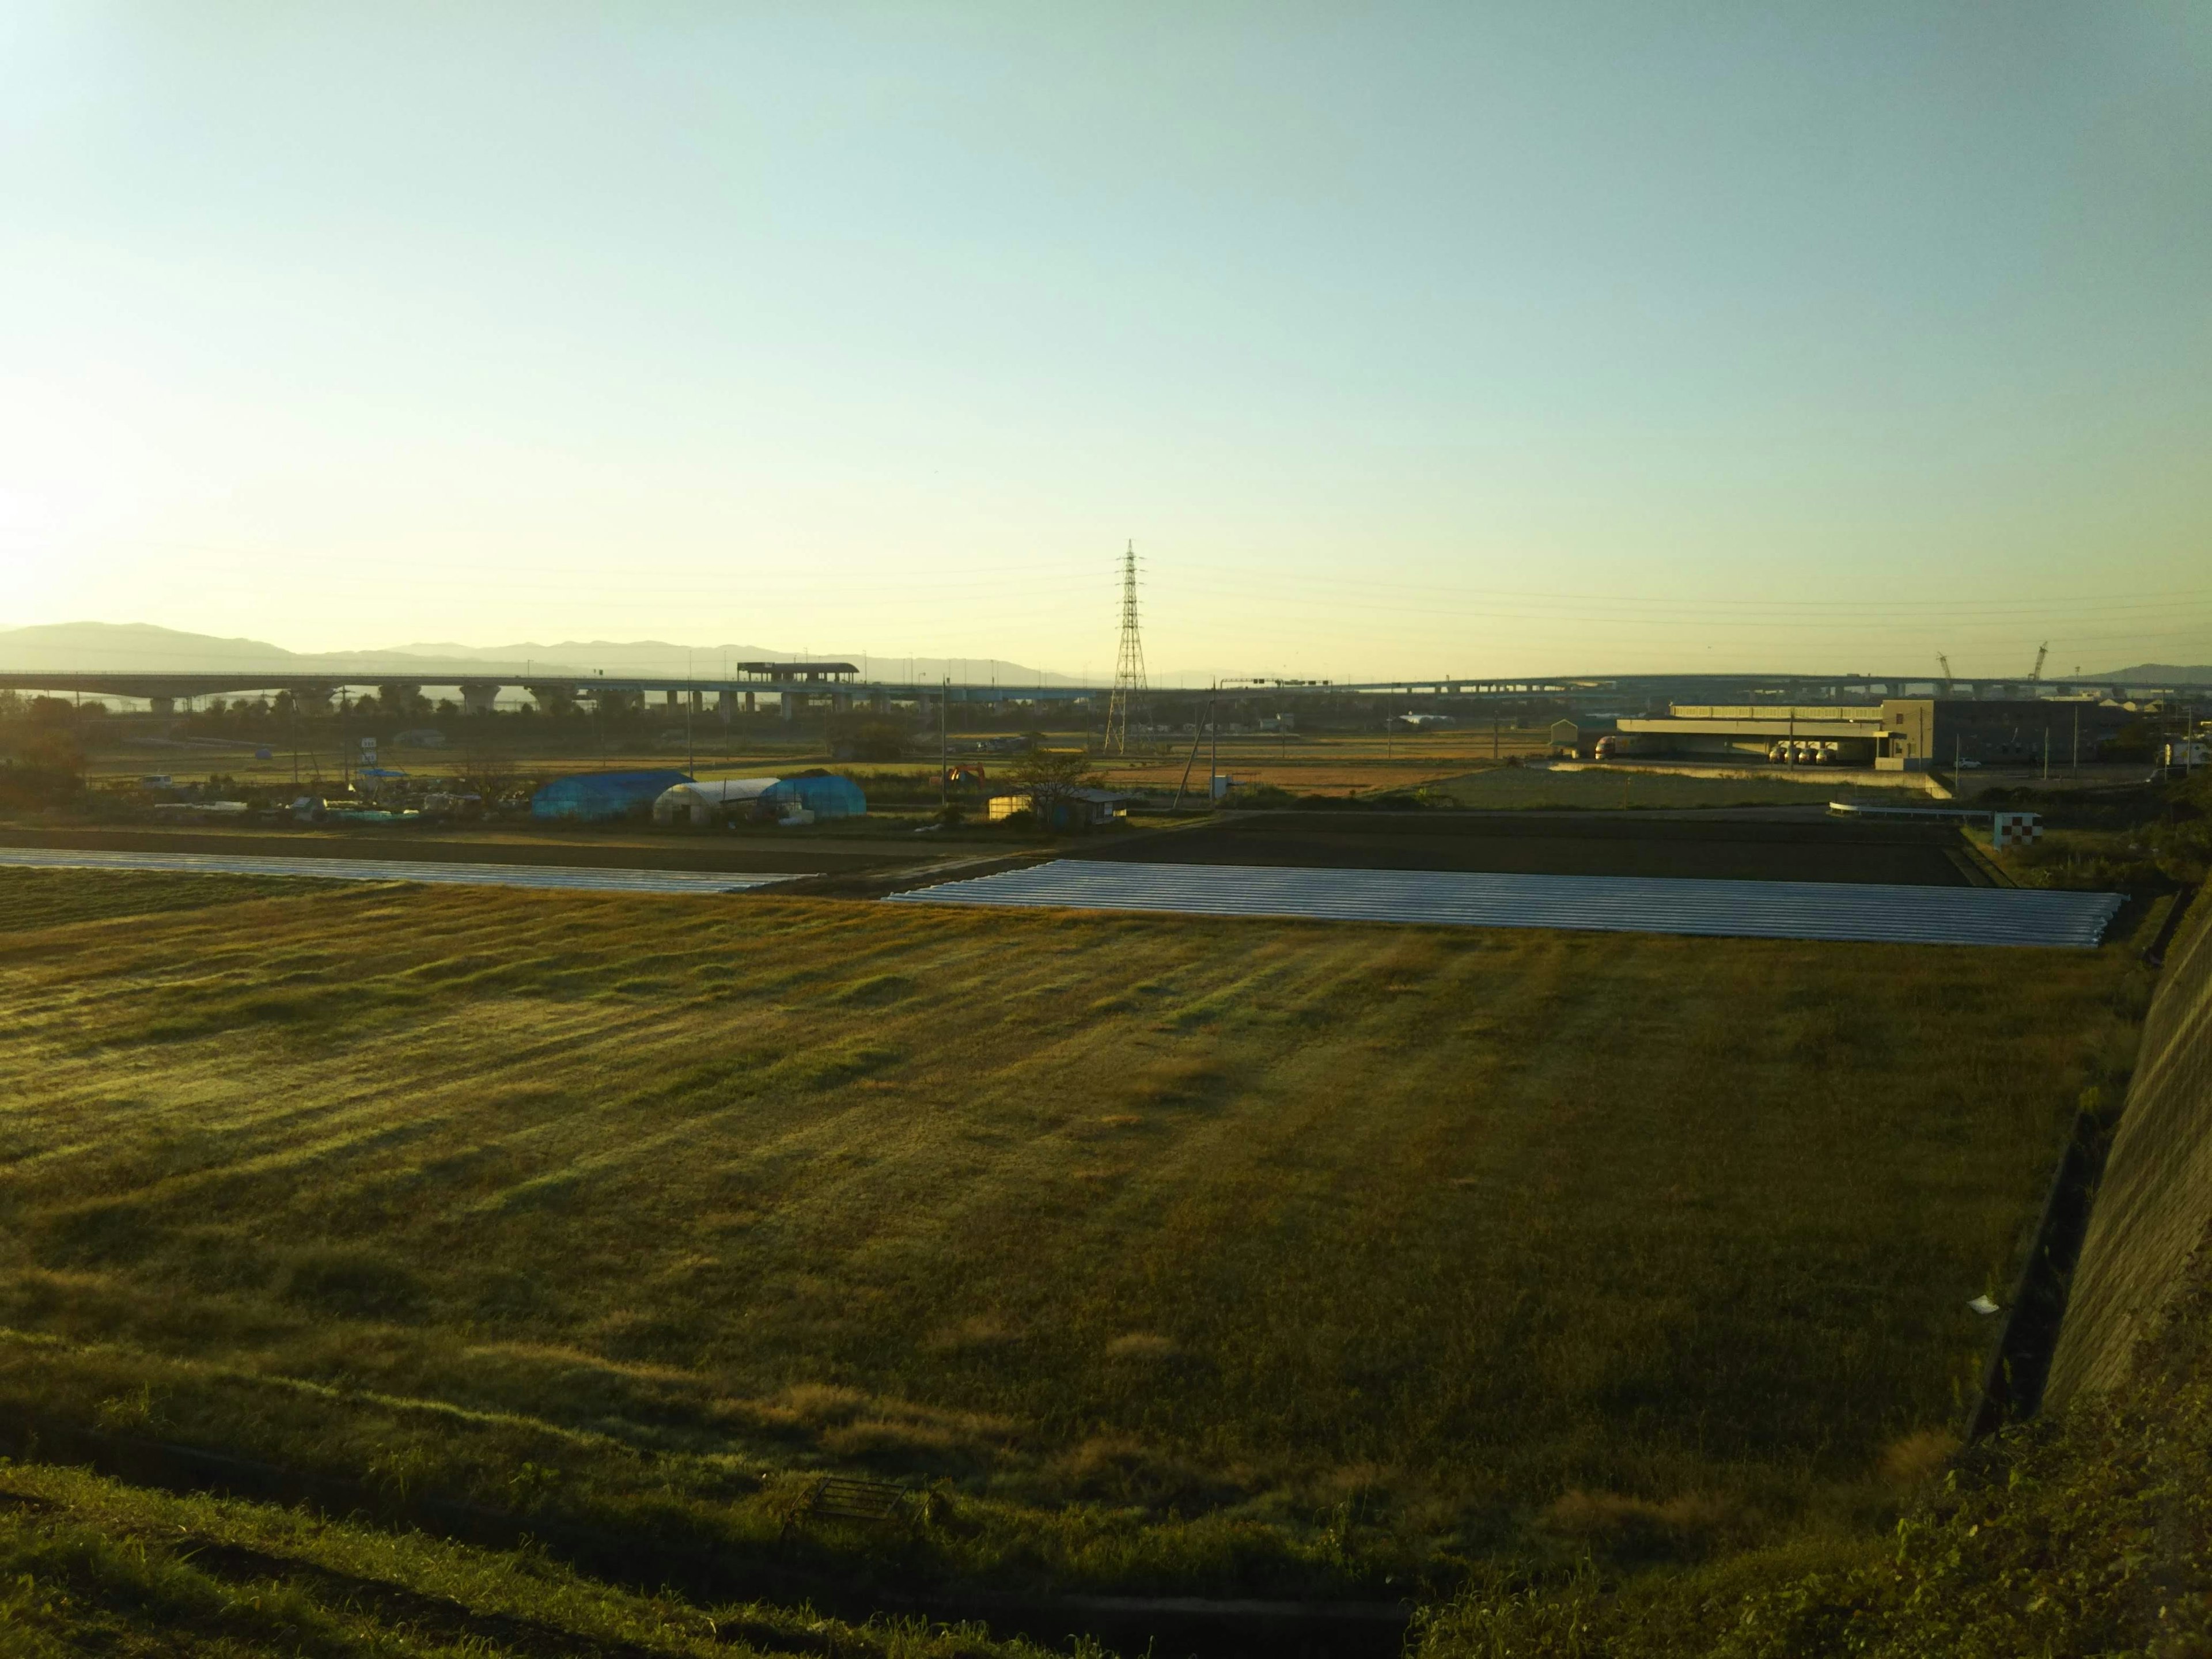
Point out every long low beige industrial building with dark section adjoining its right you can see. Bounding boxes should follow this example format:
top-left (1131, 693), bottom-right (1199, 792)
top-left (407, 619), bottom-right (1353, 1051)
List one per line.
top-left (1551, 697), bottom-right (2137, 772)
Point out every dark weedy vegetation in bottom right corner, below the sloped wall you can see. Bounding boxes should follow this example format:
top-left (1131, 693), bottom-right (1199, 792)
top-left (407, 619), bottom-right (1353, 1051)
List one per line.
top-left (1416, 1230), bottom-right (2212, 1659)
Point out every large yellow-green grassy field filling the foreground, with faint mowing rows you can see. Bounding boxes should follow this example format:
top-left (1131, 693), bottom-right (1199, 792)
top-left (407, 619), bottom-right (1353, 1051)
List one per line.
top-left (0, 872), bottom-right (2137, 1595)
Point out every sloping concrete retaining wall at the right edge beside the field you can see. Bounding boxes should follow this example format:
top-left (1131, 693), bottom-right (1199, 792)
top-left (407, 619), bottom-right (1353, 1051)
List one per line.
top-left (2044, 893), bottom-right (2212, 1407)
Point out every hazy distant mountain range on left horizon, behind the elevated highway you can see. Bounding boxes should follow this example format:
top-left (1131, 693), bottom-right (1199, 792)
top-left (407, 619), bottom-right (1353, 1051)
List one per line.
top-left (0, 622), bottom-right (1071, 685)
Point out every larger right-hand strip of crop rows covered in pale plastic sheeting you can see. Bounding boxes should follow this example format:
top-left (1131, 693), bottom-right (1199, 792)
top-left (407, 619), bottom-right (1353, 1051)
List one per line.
top-left (889, 858), bottom-right (2122, 947)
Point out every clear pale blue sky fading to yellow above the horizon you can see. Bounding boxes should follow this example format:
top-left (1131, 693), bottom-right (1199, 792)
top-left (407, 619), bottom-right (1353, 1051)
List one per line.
top-left (0, 0), bottom-right (2212, 677)
